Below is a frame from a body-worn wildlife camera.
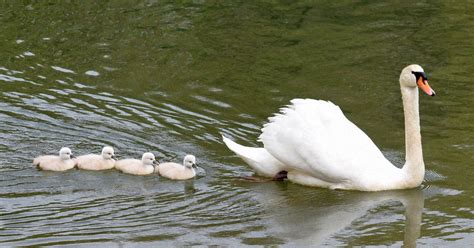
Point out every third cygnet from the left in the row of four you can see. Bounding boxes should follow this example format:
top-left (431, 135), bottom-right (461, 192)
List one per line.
top-left (115, 152), bottom-right (156, 176)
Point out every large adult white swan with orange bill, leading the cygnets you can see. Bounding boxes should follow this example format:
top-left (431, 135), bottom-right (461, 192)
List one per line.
top-left (223, 65), bottom-right (435, 191)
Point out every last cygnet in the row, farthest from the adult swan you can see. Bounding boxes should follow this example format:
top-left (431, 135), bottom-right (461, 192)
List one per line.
top-left (33, 147), bottom-right (77, 171)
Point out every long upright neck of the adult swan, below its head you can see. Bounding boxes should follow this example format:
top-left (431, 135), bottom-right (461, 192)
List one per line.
top-left (401, 87), bottom-right (425, 185)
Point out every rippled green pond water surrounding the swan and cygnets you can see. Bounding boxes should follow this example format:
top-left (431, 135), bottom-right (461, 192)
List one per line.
top-left (0, 1), bottom-right (474, 247)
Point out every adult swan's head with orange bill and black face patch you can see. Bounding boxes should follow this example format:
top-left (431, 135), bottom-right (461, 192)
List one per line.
top-left (400, 65), bottom-right (436, 96)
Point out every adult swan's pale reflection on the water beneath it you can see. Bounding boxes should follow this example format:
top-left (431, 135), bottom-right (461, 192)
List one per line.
top-left (244, 183), bottom-right (456, 247)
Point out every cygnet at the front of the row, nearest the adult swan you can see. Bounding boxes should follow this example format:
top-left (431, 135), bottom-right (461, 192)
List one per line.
top-left (155, 155), bottom-right (197, 180)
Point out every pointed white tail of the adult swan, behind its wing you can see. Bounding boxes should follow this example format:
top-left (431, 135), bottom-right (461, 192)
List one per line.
top-left (222, 136), bottom-right (284, 177)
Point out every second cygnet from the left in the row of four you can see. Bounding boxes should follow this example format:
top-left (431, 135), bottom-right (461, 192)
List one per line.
top-left (77, 146), bottom-right (115, 170)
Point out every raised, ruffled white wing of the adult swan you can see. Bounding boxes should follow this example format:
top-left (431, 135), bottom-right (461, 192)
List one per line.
top-left (260, 99), bottom-right (389, 183)
